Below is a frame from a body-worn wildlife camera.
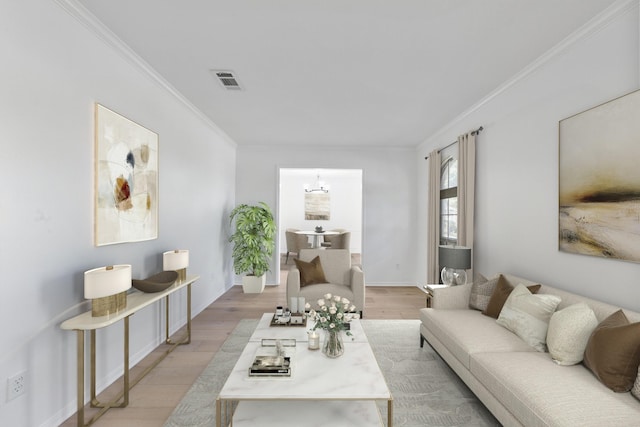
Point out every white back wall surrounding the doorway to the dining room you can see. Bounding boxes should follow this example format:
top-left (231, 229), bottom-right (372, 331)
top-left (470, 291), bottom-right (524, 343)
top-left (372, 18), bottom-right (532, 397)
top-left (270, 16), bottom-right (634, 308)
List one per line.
top-left (236, 146), bottom-right (417, 285)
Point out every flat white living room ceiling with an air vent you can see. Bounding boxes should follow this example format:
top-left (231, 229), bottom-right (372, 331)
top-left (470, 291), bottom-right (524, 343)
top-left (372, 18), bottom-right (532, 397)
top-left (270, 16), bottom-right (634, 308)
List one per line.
top-left (77, 0), bottom-right (614, 147)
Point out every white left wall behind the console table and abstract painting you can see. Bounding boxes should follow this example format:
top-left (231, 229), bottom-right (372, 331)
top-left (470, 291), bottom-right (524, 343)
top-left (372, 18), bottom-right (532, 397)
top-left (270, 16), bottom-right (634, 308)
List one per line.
top-left (0, 0), bottom-right (235, 427)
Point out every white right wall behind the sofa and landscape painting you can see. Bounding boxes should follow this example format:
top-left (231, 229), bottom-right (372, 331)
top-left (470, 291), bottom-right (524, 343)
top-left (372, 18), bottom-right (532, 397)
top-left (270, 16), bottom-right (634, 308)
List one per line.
top-left (418, 1), bottom-right (640, 310)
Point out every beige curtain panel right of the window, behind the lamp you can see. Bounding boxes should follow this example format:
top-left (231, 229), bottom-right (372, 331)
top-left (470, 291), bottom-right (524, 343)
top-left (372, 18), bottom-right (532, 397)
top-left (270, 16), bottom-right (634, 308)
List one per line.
top-left (458, 132), bottom-right (477, 281)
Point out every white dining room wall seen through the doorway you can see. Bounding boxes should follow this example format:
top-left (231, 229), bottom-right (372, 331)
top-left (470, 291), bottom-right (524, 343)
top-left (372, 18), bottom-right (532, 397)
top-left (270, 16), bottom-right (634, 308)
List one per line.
top-left (278, 169), bottom-right (362, 253)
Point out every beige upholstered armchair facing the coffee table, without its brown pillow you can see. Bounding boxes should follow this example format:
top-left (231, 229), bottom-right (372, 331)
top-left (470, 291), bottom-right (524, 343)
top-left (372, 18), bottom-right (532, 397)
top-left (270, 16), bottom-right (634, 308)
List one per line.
top-left (287, 249), bottom-right (365, 314)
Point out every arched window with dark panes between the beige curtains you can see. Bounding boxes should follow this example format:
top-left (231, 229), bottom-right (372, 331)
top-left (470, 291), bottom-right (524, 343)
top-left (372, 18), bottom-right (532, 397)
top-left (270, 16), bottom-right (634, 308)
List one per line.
top-left (440, 155), bottom-right (458, 245)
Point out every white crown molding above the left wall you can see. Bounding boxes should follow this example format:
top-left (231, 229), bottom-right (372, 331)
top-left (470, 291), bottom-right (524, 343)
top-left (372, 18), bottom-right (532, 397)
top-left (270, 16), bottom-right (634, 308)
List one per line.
top-left (53, 0), bottom-right (237, 148)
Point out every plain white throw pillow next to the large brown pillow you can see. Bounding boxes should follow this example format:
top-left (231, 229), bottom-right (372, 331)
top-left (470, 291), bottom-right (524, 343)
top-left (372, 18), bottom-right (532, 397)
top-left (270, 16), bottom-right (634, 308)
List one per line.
top-left (547, 302), bottom-right (598, 365)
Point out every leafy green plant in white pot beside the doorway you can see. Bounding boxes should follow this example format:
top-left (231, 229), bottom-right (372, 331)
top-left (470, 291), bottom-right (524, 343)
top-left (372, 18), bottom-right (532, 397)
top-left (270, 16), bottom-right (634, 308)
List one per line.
top-left (229, 202), bottom-right (276, 293)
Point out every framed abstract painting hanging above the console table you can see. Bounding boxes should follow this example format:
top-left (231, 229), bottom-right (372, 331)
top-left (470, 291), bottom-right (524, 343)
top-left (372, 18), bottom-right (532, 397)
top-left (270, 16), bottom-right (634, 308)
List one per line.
top-left (94, 104), bottom-right (158, 246)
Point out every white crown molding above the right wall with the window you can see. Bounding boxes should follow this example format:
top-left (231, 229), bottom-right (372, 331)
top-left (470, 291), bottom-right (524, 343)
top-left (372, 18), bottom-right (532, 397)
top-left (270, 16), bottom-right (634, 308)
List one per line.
top-left (417, 0), bottom-right (640, 150)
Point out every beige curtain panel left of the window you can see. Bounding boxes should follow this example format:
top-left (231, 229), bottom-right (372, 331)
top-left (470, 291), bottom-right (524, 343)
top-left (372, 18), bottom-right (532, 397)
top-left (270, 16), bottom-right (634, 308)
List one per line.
top-left (427, 150), bottom-right (441, 283)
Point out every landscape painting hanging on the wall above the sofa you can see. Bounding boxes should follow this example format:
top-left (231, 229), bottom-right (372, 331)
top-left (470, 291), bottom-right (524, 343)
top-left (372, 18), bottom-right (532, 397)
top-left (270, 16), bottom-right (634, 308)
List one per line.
top-left (559, 91), bottom-right (640, 262)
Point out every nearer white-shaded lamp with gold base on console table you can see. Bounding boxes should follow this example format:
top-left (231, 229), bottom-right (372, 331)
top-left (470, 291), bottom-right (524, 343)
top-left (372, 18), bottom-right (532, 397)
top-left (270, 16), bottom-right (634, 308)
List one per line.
top-left (84, 264), bottom-right (131, 317)
